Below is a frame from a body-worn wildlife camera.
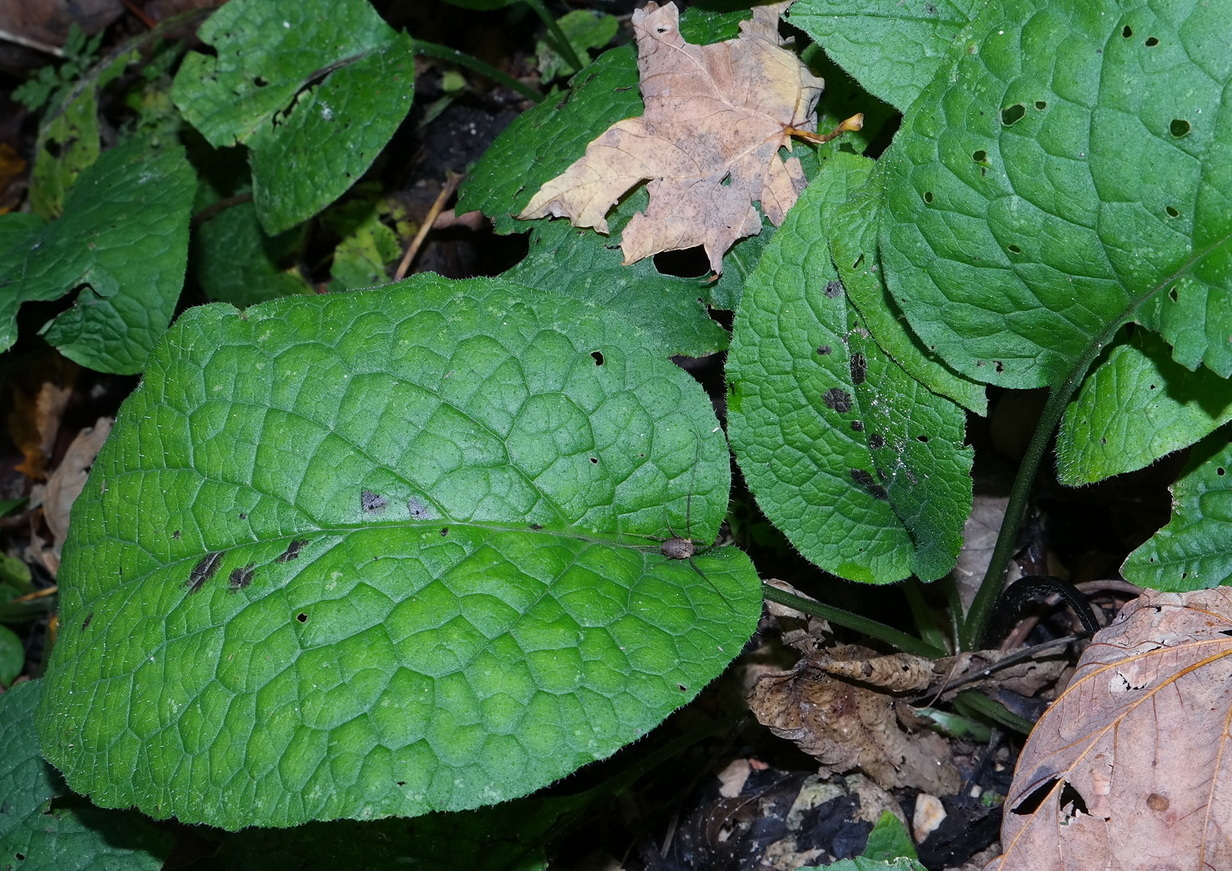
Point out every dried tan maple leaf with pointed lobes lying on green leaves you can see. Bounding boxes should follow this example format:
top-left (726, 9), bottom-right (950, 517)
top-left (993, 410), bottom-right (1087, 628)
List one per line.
top-left (517, 0), bottom-right (827, 272)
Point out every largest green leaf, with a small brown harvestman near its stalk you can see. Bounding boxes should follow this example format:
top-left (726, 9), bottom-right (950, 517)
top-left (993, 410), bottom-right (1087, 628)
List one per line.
top-left (39, 275), bottom-right (761, 829)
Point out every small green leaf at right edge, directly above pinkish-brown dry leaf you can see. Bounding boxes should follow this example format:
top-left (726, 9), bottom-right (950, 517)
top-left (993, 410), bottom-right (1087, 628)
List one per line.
top-left (1121, 429), bottom-right (1232, 591)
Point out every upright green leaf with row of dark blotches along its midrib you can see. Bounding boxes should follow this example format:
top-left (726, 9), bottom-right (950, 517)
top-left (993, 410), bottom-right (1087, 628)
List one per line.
top-left (727, 170), bottom-right (972, 583)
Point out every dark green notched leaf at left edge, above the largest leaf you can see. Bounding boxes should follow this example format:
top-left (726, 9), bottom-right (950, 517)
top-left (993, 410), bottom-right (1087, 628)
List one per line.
top-left (0, 139), bottom-right (196, 375)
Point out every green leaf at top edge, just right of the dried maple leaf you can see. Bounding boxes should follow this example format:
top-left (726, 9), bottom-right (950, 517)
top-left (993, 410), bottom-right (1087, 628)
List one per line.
top-left (787, 0), bottom-right (979, 112)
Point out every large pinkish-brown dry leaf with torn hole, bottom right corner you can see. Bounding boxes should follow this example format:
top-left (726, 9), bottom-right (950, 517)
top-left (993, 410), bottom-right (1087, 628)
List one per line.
top-left (986, 588), bottom-right (1232, 871)
